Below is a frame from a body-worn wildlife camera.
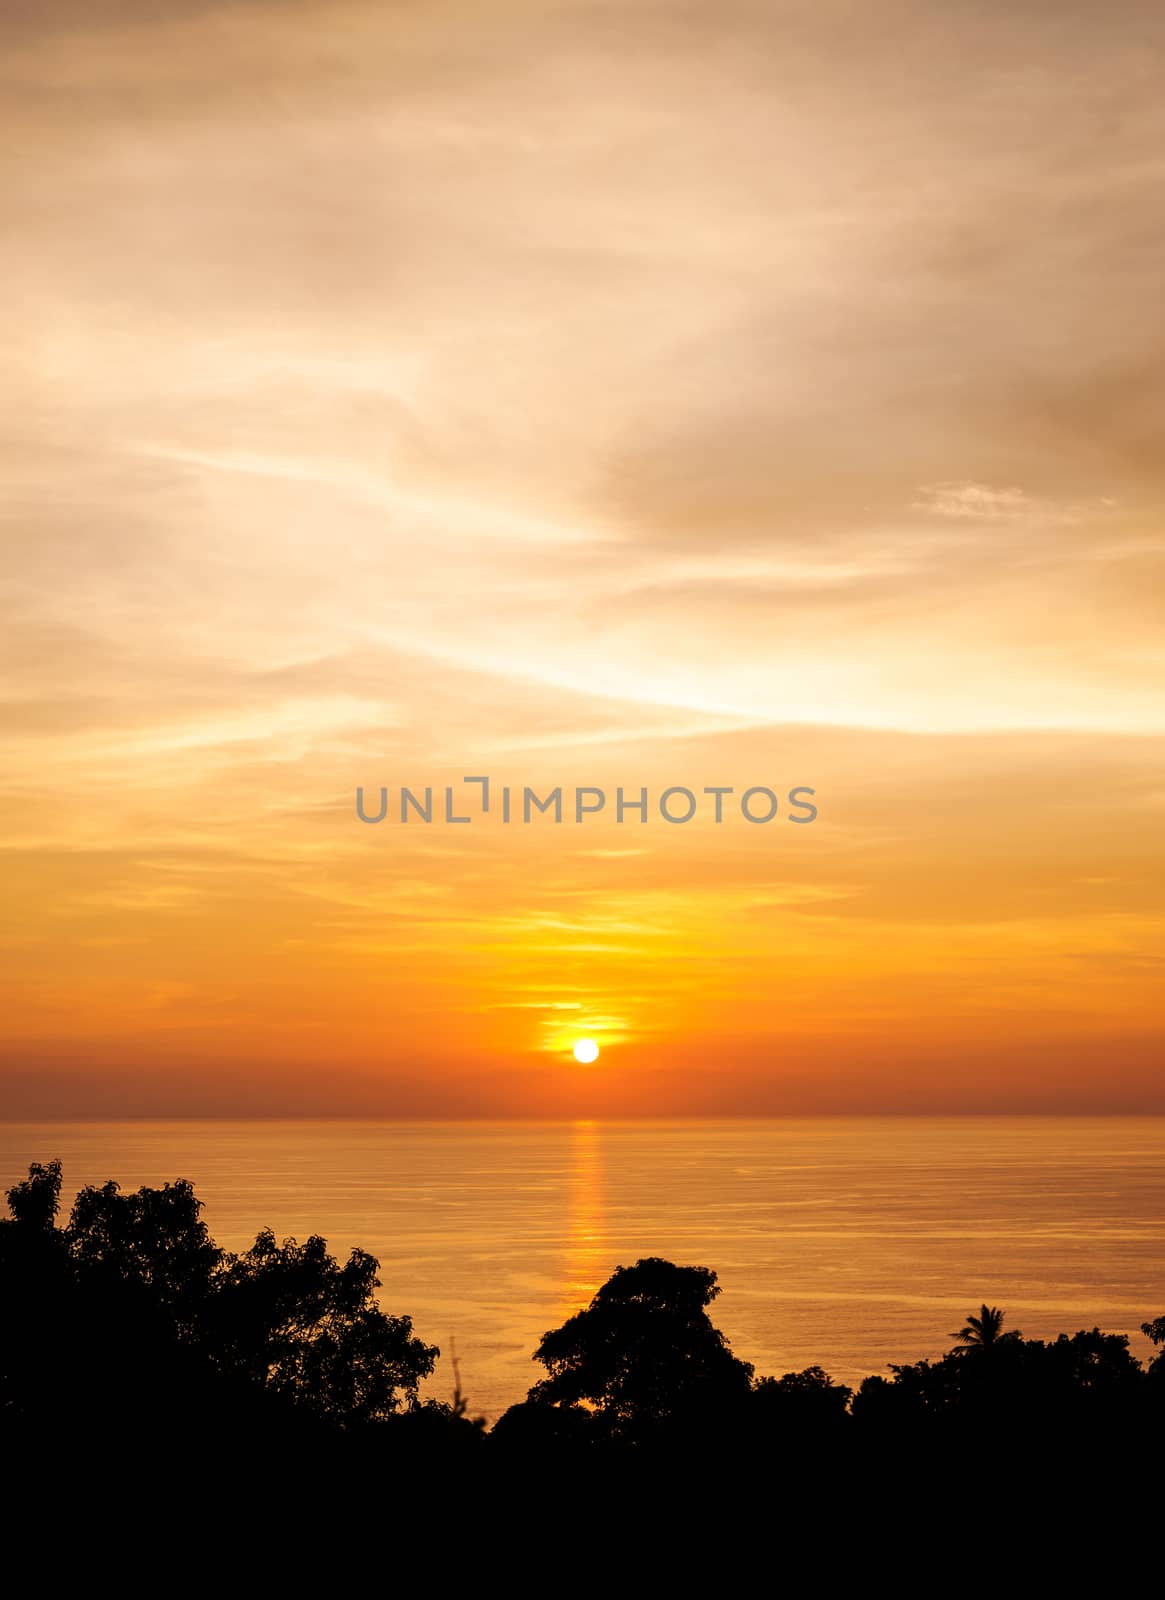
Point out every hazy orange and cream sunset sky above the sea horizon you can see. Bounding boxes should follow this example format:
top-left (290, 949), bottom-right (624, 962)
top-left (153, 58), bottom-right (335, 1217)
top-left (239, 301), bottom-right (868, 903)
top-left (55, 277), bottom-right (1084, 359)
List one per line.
top-left (0, 0), bottom-right (1165, 1118)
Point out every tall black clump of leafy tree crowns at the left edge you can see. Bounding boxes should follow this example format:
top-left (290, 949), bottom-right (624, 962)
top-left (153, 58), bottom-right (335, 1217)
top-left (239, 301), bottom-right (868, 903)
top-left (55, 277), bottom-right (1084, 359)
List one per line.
top-left (0, 1162), bottom-right (435, 1429)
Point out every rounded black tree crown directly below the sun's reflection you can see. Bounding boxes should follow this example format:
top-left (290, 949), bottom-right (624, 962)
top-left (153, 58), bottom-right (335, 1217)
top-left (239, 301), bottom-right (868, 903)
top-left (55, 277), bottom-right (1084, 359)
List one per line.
top-left (530, 1256), bottom-right (752, 1438)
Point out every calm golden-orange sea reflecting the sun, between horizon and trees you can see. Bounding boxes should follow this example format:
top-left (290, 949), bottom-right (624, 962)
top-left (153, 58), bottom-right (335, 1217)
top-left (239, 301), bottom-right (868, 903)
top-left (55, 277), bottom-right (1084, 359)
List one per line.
top-left (0, 1117), bottom-right (1165, 1418)
